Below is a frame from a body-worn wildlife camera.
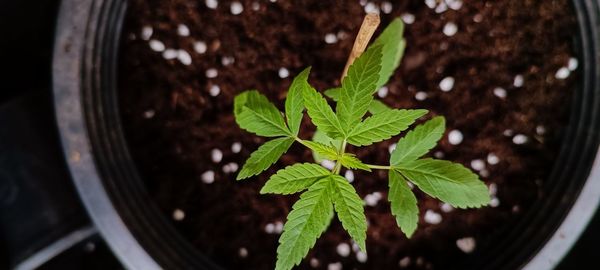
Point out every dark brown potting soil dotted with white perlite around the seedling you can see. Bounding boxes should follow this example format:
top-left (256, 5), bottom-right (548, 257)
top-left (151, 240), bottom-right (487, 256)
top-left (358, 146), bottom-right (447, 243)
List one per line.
top-left (119, 0), bottom-right (577, 269)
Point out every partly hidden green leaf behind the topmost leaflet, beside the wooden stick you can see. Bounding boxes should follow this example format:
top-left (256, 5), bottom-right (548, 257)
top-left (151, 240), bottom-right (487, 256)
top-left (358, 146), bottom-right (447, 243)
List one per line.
top-left (371, 18), bottom-right (406, 89)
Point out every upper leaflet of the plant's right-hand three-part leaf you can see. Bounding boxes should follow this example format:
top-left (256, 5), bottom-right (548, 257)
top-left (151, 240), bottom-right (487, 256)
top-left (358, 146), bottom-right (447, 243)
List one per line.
top-left (390, 116), bottom-right (446, 165)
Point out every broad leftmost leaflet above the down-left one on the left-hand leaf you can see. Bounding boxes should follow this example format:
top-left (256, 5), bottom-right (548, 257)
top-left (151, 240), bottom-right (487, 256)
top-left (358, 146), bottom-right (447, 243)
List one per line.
top-left (234, 90), bottom-right (291, 137)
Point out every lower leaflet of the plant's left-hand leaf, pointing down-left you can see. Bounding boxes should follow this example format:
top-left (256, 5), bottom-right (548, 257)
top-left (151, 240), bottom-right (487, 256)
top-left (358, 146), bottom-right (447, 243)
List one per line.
top-left (237, 138), bottom-right (294, 180)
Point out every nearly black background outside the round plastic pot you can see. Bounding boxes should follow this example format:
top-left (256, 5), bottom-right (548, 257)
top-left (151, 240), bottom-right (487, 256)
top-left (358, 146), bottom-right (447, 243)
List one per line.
top-left (0, 0), bottom-right (600, 270)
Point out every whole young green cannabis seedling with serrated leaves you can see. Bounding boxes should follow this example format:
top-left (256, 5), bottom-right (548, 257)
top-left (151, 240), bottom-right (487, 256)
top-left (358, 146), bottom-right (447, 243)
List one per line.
top-left (234, 19), bottom-right (490, 270)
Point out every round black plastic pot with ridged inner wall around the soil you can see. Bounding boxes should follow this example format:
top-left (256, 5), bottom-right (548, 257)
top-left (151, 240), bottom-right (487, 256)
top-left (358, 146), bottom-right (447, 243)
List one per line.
top-left (53, 0), bottom-right (600, 270)
